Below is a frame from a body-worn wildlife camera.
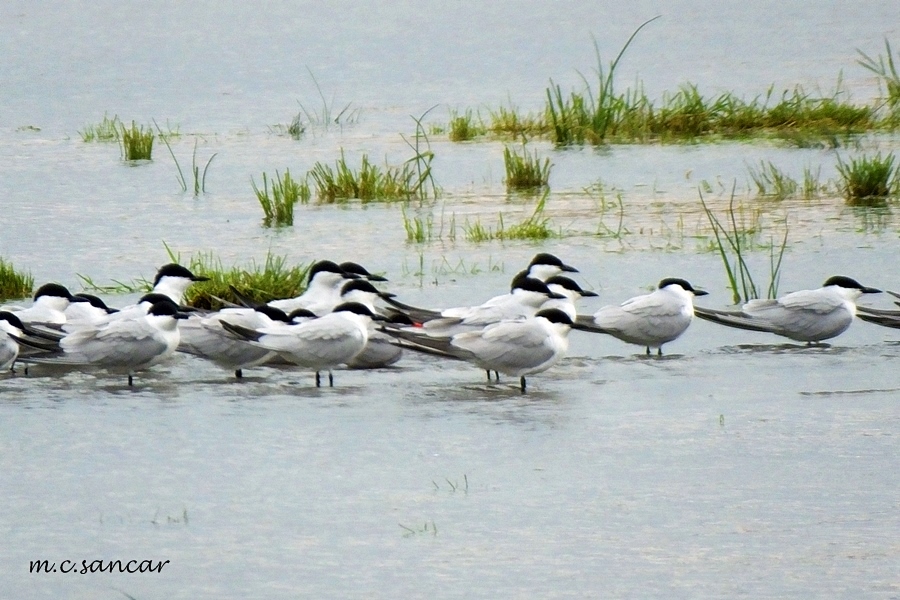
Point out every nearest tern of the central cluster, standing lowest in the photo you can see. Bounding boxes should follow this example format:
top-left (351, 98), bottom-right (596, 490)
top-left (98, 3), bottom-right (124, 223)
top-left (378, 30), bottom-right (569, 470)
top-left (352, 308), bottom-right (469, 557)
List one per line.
top-left (385, 308), bottom-right (574, 394)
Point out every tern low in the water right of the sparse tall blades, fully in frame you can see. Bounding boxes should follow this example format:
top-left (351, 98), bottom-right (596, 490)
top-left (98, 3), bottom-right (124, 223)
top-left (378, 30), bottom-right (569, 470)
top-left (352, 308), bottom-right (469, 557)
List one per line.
top-left (694, 276), bottom-right (881, 344)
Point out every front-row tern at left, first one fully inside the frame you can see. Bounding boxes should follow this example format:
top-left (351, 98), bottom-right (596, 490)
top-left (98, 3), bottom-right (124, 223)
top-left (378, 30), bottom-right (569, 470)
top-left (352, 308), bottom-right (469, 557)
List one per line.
top-left (17, 298), bottom-right (186, 386)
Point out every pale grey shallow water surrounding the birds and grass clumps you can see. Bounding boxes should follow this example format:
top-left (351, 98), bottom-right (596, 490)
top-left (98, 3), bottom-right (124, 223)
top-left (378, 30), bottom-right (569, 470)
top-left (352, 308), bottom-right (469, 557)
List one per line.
top-left (0, 1), bottom-right (900, 599)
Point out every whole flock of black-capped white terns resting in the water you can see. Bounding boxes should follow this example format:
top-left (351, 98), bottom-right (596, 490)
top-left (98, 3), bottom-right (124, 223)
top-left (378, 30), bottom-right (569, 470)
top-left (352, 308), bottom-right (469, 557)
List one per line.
top-left (0, 253), bottom-right (888, 393)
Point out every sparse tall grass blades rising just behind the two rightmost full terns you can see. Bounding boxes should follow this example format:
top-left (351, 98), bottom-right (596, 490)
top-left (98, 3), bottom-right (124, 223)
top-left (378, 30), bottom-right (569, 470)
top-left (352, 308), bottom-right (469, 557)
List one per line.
top-left (700, 189), bottom-right (788, 304)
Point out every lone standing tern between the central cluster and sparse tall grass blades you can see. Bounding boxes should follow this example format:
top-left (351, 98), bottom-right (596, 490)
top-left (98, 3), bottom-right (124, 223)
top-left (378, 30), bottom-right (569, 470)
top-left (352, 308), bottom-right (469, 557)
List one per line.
top-left (575, 277), bottom-right (707, 356)
